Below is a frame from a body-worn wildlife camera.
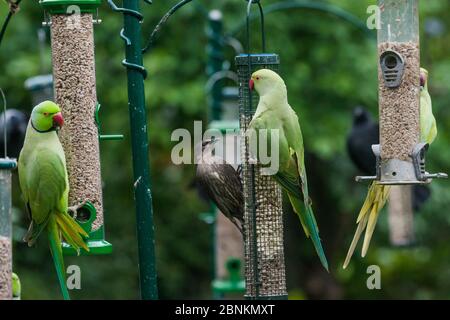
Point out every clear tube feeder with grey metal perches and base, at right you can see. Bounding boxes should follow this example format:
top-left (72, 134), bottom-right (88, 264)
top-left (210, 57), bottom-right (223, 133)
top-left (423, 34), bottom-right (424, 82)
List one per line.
top-left (359, 0), bottom-right (446, 185)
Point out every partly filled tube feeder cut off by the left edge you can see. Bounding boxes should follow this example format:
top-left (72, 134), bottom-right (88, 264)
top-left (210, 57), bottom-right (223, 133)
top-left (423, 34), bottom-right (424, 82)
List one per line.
top-left (0, 158), bottom-right (17, 300)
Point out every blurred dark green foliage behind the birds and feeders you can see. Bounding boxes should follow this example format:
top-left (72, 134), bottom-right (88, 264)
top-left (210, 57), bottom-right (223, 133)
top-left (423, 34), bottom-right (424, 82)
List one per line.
top-left (0, 0), bottom-right (450, 299)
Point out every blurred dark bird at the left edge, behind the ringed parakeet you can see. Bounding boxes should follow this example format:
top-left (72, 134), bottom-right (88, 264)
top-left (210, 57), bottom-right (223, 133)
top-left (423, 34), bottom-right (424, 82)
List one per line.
top-left (0, 109), bottom-right (29, 159)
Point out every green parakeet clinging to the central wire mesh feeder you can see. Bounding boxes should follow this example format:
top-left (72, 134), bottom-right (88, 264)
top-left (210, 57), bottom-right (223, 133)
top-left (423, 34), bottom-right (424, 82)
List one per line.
top-left (248, 69), bottom-right (328, 270)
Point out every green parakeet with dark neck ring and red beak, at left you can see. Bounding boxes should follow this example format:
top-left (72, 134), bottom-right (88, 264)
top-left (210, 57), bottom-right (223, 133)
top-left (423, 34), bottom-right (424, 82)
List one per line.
top-left (18, 101), bottom-right (89, 299)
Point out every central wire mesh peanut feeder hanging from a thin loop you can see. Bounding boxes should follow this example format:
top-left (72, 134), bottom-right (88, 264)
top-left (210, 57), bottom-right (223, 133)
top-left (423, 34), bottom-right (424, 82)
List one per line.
top-left (236, 1), bottom-right (287, 299)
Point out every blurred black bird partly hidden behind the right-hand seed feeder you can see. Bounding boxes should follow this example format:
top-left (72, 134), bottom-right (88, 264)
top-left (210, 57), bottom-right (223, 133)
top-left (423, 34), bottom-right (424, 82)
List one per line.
top-left (347, 107), bottom-right (431, 211)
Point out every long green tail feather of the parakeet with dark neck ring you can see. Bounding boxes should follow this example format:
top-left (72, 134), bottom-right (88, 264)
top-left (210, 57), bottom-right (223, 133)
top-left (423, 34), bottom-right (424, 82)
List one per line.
top-left (47, 215), bottom-right (70, 300)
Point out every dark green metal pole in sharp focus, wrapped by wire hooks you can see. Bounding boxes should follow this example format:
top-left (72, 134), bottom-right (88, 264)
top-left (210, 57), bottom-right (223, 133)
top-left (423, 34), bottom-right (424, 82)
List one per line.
top-left (123, 0), bottom-right (158, 300)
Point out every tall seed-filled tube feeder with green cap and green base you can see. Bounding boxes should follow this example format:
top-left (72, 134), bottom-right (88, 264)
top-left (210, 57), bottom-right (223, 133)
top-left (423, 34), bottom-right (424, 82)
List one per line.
top-left (40, 0), bottom-right (112, 255)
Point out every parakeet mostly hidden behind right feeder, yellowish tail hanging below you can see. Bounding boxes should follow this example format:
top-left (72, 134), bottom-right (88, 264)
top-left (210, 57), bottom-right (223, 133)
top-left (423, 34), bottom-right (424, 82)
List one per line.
top-left (343, 68), bottom-right (437, 269)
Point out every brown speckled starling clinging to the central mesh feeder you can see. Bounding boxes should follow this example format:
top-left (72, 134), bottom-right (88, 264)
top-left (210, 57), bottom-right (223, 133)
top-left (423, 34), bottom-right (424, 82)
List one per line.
top-left (196, 139), bottom-right (244, 233)
